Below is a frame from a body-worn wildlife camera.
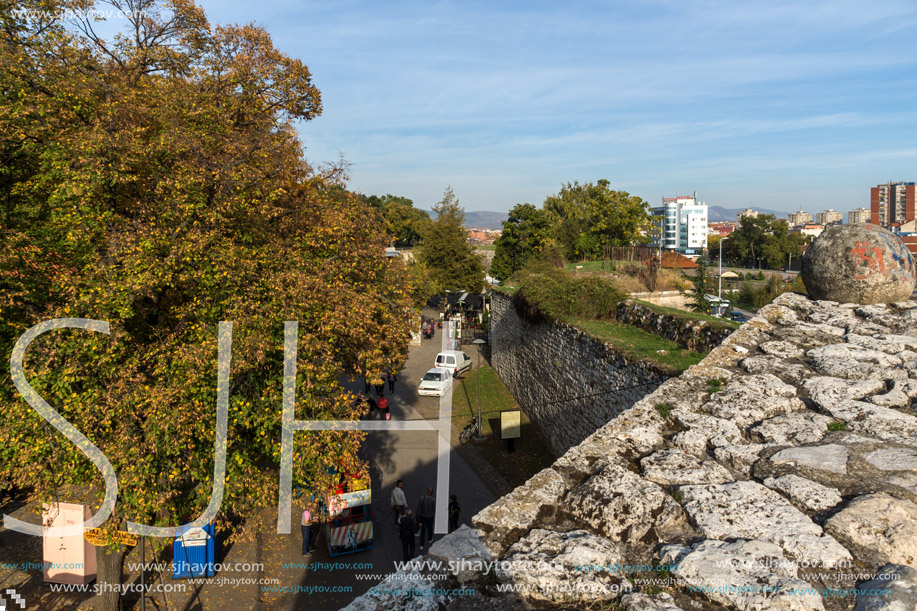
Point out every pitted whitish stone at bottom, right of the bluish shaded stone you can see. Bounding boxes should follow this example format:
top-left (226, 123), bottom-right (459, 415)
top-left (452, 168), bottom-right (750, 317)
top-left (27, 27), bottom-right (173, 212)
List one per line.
top-left (494, 529), bottom-right (626, 603)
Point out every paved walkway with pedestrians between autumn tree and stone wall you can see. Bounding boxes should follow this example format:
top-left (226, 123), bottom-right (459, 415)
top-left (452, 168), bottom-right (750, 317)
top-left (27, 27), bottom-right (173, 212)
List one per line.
top-left (160, 310), bottom-right (497, 611)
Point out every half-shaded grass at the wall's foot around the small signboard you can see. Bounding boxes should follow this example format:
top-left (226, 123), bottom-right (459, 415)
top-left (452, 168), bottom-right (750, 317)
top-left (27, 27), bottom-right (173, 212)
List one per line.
top-left (452, 364), bottom-right (554, 487)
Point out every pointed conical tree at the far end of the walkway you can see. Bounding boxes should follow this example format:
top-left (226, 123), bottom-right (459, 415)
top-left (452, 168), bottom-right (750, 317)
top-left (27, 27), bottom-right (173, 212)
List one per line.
top-left (417, 187), bottom-right (484, 293)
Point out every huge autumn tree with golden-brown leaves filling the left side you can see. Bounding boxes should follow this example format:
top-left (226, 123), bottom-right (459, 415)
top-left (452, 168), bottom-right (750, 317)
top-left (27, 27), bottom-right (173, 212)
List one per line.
top-left (0, 0), bottom-right (411, 610)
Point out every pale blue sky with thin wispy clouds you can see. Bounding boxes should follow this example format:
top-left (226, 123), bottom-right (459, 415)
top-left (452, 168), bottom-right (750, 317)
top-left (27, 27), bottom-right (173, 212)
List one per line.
top-left (200, 0), bottom-right (917, 212)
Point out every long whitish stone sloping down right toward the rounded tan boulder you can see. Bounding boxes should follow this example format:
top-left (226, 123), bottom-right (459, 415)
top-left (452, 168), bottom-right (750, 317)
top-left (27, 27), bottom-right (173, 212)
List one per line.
top-left (680, 481), bottom-right (851, 566)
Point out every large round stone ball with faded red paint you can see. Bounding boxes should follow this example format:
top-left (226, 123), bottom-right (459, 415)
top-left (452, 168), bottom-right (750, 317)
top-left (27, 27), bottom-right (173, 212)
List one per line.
top-left (802, 223), bottom-right (917, 304)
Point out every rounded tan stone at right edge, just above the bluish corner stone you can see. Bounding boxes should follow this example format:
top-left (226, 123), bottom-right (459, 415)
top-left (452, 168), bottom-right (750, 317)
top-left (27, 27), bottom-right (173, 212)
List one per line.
top-left (825, 493), bottom-right (917, 567)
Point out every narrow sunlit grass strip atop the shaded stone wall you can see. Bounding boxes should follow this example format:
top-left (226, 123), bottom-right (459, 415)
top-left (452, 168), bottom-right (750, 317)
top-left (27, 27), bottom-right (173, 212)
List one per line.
top-left (567, 319), bottom-right (707, 371)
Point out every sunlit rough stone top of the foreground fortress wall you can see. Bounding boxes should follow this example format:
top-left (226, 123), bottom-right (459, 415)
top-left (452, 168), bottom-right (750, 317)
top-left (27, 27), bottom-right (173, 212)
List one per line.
top-left (348, 293), bottom-right (917, 611)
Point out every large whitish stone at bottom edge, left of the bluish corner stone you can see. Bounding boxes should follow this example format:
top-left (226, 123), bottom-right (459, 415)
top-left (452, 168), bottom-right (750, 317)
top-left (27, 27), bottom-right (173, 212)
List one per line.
top-left (661, 539), bottom-right (824, 611)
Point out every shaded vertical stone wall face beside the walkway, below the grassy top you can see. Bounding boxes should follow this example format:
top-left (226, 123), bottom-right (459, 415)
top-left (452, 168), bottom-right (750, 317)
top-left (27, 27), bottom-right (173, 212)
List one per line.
top-left (490, 291), bottom-right (671, 456)
